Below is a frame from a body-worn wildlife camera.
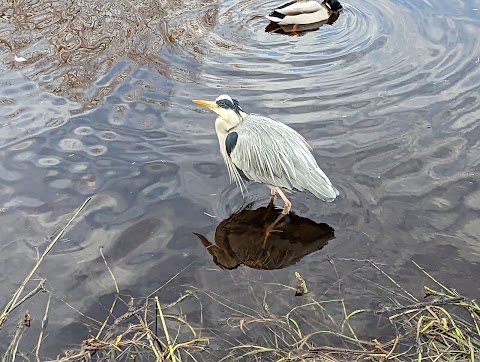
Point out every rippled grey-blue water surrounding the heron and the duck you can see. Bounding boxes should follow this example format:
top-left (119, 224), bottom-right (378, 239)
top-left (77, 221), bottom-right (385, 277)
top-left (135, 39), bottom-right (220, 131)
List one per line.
top-left (0, 0), bottom-right (480, 357)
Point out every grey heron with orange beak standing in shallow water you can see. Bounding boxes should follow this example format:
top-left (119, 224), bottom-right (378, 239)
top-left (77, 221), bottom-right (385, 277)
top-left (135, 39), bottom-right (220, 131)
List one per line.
top-left (193, 94), bottom-right (338, 240)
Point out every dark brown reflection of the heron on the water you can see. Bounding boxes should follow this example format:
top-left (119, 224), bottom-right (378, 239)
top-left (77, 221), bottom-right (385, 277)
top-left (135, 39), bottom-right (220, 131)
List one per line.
top-left (195, 203), bottom-right (335, 270)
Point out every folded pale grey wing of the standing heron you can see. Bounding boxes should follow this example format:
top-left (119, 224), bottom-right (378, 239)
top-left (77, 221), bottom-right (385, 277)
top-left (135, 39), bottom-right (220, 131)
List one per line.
top-left (226, 114), bottom-right (336, 201)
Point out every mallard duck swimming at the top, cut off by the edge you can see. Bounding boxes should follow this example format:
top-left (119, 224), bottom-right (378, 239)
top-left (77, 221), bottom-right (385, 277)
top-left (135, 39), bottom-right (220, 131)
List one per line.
top-left (266, 0), bottom-right (342, 31)
